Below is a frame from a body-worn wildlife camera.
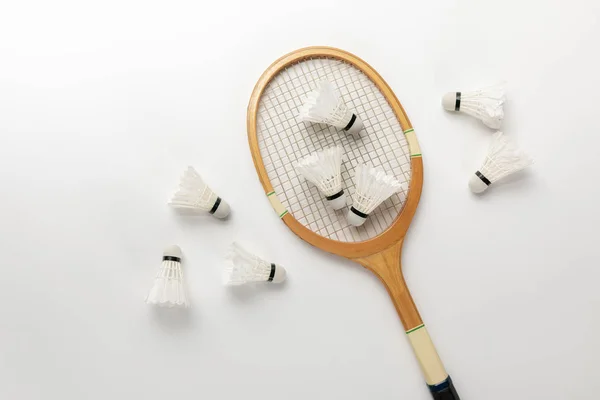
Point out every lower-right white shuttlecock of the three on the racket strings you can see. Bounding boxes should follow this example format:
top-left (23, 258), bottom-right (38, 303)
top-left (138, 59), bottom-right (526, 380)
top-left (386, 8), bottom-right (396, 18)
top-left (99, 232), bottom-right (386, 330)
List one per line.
top-left (348, 164), bottom-right (403, 226)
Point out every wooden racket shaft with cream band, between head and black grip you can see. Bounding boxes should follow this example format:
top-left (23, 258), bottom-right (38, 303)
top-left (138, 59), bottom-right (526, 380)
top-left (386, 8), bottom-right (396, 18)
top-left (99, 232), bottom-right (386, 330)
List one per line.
top-left (355, 241), bottom-right (449, 388)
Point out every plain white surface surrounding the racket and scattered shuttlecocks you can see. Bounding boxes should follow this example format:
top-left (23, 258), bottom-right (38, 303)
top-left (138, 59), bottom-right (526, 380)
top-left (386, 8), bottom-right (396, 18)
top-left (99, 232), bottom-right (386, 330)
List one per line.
top-left (0, 0), bottom-right (600, 400)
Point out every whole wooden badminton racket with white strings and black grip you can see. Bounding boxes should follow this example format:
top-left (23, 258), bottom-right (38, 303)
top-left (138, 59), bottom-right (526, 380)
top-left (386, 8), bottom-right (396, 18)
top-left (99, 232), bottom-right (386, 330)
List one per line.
top-left (247, 47), bottom-right (459, 400)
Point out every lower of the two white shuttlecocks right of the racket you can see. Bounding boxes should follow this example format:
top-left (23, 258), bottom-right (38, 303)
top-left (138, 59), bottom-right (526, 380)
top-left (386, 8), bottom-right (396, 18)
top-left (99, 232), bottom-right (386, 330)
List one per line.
top-left (469, 131), bottom-right (533, 193)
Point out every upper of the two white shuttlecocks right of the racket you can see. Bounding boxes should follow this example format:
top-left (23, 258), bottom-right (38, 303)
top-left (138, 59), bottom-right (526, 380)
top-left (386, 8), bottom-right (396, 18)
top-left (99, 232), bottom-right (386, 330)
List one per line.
top-left (442, 83), bottom-right (506, 129)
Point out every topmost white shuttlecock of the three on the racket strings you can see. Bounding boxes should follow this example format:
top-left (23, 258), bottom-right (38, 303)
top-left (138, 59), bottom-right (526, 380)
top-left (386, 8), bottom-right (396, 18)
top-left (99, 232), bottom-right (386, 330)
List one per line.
top-left (299, 81), bottom-right (363, 137)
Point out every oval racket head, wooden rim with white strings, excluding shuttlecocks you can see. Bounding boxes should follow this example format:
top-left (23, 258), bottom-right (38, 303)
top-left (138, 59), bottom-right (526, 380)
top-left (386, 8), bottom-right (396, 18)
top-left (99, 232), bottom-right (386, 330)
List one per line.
top-left (247, 47), bottom-right (423, 259)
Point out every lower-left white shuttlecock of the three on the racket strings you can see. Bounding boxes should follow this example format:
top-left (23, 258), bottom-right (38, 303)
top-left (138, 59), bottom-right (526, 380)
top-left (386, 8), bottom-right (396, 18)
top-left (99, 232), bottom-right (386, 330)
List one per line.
top-left (296, 146), bottom-right (346, 210)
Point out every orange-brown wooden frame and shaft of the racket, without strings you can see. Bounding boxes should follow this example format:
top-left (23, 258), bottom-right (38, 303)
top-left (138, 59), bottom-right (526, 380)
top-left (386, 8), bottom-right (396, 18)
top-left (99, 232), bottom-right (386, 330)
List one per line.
top-left (247, 46), bottom-right (448, 385)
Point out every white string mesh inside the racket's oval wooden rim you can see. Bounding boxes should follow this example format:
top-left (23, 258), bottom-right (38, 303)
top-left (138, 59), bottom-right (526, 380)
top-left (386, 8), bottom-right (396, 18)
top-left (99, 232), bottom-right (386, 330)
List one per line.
top-left (256, 58), bottom-right (411, 242)
